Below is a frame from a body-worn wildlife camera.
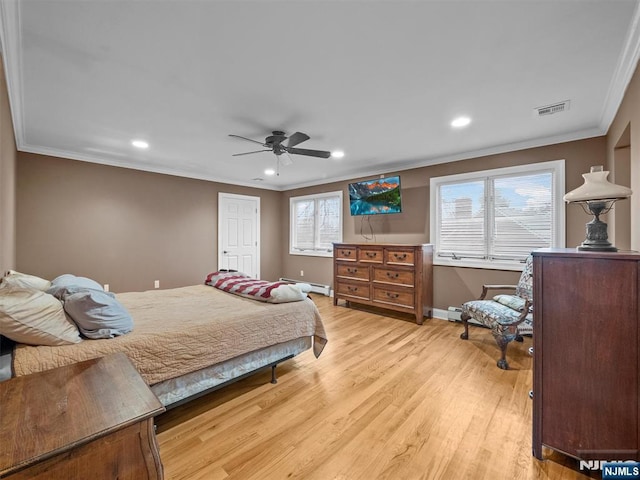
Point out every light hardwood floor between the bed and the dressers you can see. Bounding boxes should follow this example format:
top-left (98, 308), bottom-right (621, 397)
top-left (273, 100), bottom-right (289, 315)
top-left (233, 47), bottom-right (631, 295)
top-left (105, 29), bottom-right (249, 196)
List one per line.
top-left (156, 295), bottom-right (596, 480)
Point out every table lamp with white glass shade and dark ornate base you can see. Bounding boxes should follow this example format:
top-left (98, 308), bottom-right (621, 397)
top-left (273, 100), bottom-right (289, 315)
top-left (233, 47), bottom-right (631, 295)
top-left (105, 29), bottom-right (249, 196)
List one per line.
top-left (563, 165), bottom-right (632, 252)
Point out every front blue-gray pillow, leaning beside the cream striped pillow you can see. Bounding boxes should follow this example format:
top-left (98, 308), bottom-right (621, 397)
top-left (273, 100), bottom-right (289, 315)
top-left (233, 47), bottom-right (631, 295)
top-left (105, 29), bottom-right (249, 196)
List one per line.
top-left (64, 287), bottom-right (133, 339)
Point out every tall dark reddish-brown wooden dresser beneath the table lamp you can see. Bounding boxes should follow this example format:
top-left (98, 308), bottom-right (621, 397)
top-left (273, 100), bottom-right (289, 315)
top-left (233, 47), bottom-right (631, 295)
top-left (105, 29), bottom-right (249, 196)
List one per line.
top-left (533, 249), bottom-right (640, 461)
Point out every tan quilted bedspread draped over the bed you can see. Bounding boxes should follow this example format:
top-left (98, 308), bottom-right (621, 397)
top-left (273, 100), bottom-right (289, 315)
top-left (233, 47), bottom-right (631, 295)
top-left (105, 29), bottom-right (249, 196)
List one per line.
top-left (13, 285), bottom-right (327, 385)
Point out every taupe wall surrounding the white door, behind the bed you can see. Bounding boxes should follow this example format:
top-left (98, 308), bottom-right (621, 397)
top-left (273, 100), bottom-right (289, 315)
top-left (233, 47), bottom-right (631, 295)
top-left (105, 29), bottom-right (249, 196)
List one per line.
top-left (16, 153), bottom-right (282, 292)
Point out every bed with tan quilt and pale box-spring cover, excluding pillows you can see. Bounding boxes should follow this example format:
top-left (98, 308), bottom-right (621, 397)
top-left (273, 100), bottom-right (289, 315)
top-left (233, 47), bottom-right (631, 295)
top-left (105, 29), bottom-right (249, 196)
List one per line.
top-left (0, 285), bottom-right (327, 408)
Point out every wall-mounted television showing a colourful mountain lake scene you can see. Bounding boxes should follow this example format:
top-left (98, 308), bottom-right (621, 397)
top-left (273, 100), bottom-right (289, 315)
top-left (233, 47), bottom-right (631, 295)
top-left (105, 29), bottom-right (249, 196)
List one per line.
top-left (349, 175), bottom-right (402, 215)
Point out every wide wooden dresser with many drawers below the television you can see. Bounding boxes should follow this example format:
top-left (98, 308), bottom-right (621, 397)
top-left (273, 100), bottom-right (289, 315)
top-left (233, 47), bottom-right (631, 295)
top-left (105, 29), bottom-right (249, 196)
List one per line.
top-left (333, 243), bottom-right (433, 325)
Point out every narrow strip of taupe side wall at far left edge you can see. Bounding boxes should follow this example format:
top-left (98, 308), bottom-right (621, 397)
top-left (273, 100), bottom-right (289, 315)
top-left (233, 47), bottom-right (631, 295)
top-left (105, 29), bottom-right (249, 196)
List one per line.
top-left (0, 56), bottom-right (17, 272)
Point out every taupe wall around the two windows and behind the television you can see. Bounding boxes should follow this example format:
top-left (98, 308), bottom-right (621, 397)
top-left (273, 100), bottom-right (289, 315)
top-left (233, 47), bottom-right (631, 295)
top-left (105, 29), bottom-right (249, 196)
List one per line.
top-left (282, 137), bottom-right (606, 309)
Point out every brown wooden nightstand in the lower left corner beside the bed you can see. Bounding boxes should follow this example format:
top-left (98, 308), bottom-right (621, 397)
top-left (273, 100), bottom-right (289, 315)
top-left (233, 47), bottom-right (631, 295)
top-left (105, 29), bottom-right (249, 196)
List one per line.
top-left (0, 350), bottom-right (164, 480)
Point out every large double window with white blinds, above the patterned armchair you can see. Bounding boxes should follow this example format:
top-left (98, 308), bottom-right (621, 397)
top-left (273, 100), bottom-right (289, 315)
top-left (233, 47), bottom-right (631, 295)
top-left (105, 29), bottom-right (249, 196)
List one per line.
top-left (431, 160), bottom-right (565, 270)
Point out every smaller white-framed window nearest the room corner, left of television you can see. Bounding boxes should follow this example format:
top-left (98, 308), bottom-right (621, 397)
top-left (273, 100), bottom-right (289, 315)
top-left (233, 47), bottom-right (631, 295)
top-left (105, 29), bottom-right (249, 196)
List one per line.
top-left (289, 192), bottom-right (342, 257)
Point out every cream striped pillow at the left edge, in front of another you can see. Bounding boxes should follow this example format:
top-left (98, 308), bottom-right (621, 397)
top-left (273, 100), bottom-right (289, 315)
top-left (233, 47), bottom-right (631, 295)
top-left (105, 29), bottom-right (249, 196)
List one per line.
top-left (0, 285), bottom-right (82, 345)
